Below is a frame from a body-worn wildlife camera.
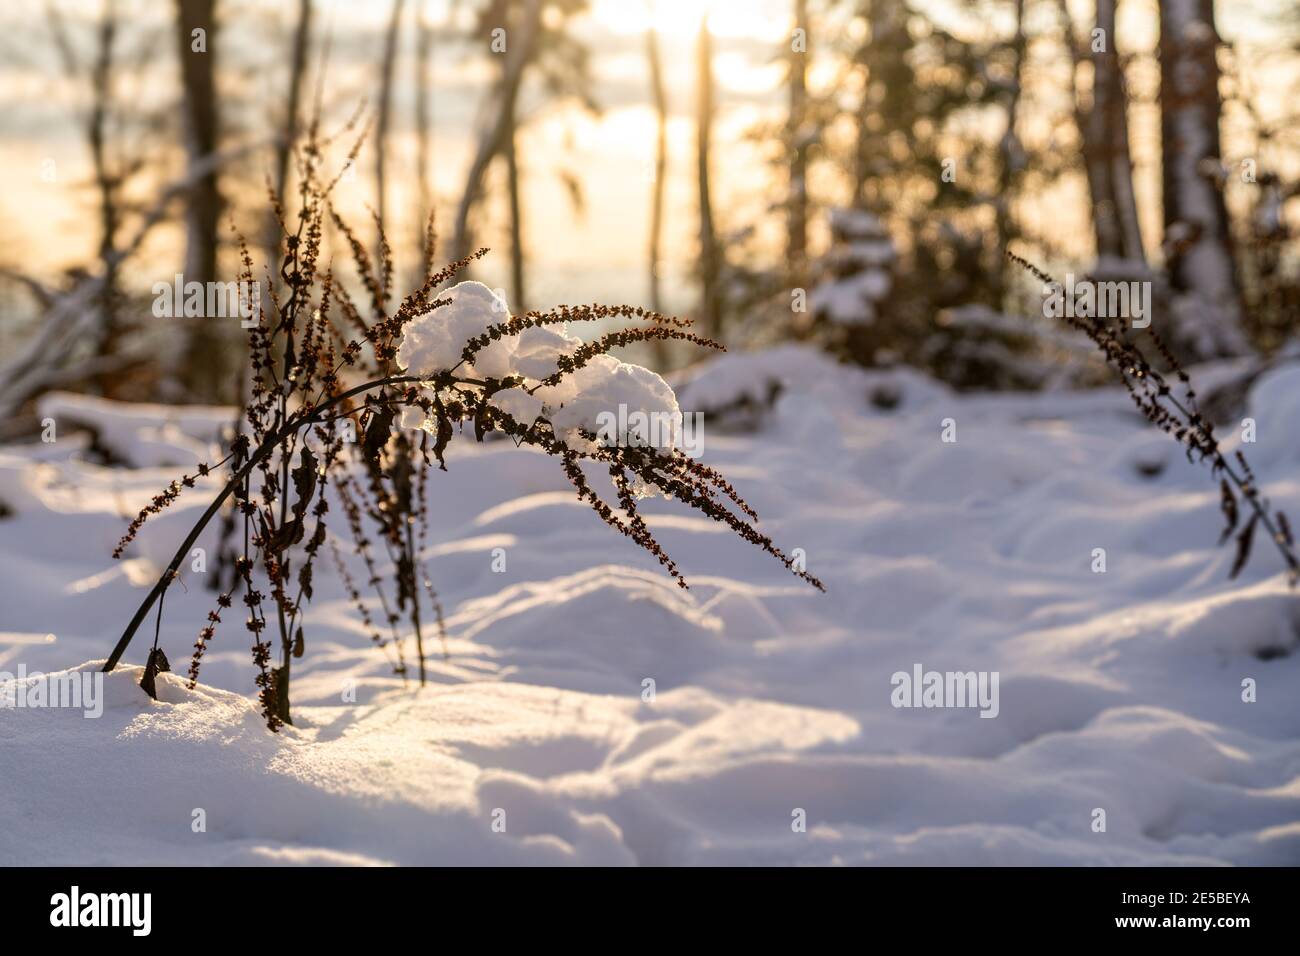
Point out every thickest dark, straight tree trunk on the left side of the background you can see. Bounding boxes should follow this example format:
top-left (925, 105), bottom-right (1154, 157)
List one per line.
top-left (176, 0), bottom-right (229, 402)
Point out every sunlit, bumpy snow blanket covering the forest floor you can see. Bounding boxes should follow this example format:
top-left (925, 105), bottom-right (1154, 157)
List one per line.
top-left (0, 347), bottom-right (1300, 865)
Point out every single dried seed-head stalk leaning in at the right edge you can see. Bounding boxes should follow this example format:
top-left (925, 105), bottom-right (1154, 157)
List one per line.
top-left (1006, 251), bottom-right (1300, 587)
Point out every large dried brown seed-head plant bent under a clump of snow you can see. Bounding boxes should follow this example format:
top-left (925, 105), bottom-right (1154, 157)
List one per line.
top-left (104, 124), bottom-right (824, 731)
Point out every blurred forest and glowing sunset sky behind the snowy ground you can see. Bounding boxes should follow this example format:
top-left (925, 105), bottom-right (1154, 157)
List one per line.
top-left (0, 0), bottom-right (1300, 436)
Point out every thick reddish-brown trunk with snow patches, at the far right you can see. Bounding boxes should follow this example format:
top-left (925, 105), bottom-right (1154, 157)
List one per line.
top-left (1160, 0), bottom-right (1245, 358)
